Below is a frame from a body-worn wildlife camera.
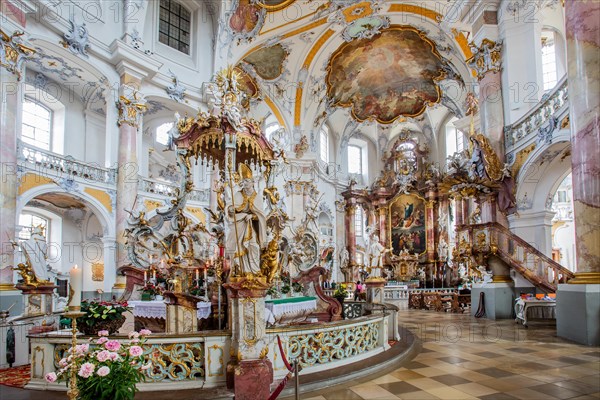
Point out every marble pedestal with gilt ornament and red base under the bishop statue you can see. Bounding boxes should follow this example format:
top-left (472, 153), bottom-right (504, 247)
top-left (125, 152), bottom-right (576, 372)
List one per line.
top-left (223, 276), bottom-right (273, 400)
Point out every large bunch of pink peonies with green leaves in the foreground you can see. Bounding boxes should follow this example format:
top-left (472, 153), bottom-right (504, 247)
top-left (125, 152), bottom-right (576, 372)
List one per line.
top-left (45, 329), bottom-right (152, 400)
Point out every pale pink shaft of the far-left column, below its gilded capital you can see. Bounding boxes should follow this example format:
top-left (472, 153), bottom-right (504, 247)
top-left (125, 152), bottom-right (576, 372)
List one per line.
top-left (0, 68), bottom-right (21, 288)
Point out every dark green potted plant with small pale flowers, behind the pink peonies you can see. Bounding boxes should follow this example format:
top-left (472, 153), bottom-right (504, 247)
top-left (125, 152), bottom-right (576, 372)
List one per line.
top-left (77, 300), bottom-right (129, 335)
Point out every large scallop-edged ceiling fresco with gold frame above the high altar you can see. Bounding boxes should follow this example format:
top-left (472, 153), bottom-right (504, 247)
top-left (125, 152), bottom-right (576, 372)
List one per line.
top-left (326, 25), bottom-right (444, 124)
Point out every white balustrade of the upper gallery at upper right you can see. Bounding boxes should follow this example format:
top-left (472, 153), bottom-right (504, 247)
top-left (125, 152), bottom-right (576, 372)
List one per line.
top-left (504, 76), bottom-right (569, 153)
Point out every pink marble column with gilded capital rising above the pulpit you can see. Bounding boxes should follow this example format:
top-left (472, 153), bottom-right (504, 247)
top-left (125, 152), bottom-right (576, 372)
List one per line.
top-left (468, 39), bottom-right (504, 161)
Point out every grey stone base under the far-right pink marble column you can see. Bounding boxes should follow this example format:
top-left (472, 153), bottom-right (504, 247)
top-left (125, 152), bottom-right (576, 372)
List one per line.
top-left (556, 284), bottom-right (600, 346)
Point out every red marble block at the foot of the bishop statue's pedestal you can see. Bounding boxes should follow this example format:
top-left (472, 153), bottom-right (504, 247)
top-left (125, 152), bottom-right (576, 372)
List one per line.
top-left (234, 359), bottom-right (273, 400)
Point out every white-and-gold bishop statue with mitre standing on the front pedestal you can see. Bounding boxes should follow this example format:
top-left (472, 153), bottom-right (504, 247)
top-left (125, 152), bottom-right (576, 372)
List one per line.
top-left (225, 164), bottom-right (268, 274)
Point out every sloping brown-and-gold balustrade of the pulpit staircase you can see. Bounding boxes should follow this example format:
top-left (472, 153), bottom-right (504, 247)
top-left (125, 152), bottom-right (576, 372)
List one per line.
top-left (458, 223), bottom-right (575, 292)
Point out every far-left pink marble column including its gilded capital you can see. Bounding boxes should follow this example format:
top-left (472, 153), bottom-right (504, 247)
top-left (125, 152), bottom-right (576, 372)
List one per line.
top-left (0, 31), bottom-right (34, 290)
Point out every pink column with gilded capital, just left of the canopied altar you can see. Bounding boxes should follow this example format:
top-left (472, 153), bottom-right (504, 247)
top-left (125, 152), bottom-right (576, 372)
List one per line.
top-left (116, 83), bottom-right (146, 268)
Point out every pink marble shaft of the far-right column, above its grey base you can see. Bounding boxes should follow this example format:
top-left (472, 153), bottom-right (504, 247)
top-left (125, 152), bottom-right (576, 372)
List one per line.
top-left (565, 0), bottom-right (600, 283)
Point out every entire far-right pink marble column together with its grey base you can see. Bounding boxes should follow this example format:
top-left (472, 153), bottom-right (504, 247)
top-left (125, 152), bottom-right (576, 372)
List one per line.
top-left (556, 0), bottom-right (600, 346)
